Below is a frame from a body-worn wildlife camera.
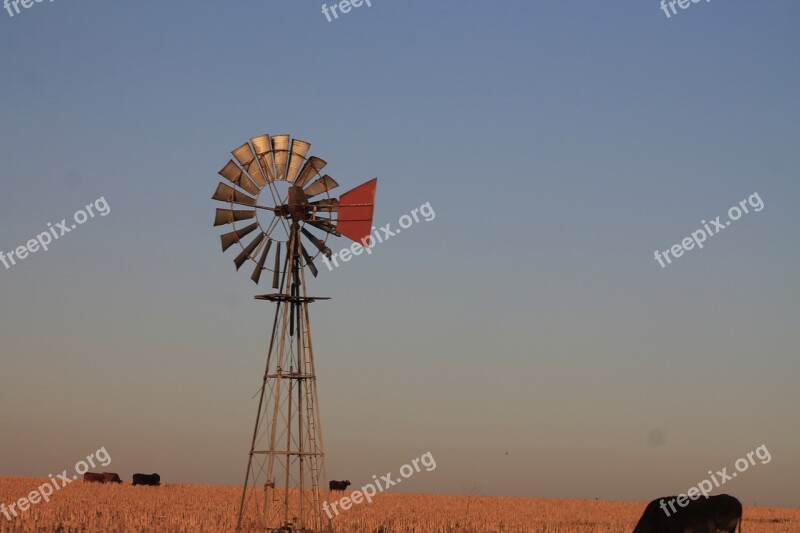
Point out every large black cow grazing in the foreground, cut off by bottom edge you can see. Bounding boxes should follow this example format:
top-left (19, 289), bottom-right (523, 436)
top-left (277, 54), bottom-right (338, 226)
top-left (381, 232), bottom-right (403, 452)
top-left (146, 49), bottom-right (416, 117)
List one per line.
top-left (633, 494), bottom-right (742, 533)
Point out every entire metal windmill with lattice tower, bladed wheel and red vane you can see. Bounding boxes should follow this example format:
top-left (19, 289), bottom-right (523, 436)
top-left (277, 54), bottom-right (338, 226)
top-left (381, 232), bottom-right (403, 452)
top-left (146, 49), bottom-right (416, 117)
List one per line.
top-left (212, 134), bottom-right (377, 532)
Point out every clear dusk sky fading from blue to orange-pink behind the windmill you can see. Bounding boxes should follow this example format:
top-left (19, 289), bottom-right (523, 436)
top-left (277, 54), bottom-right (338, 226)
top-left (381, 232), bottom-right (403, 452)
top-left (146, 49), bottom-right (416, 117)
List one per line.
top-left (0, 0), bottom-right (800, 507)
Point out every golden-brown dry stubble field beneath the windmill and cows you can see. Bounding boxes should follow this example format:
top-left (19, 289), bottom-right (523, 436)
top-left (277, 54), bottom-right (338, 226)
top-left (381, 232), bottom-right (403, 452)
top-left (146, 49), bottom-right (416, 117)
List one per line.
top-left (0, 478), bottom-right (800, 533)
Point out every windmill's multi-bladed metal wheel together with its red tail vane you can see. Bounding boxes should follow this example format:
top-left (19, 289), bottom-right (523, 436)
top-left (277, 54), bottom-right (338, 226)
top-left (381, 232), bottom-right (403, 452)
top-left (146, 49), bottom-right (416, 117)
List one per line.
top-left (212, 134), bottom-right (377, 288)
